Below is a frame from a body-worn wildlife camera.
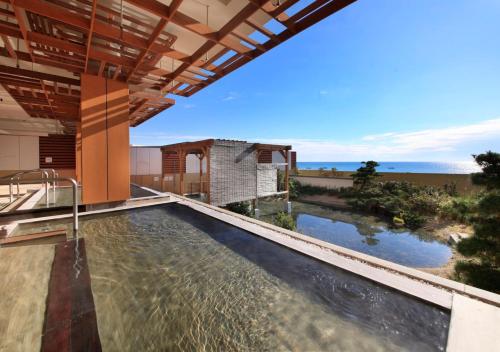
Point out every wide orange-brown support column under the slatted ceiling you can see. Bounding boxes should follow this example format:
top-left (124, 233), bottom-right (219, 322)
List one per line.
top-left (81, 74), bottom-right (130, 204)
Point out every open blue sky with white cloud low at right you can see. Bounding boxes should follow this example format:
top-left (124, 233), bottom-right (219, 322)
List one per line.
top-left (131, 0), bottom-right (500, 161)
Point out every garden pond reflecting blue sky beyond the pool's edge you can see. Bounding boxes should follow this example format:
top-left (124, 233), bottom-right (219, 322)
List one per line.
top-left (260, 202), bottom-right (452, 268)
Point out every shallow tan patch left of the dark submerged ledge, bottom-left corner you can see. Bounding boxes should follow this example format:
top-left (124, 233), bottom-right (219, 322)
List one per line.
top-left (0, 245), bottom-right (54, 352)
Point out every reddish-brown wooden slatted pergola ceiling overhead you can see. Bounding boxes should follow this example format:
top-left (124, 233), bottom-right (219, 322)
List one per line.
top-left (0, 0), bottom-right (356, 129)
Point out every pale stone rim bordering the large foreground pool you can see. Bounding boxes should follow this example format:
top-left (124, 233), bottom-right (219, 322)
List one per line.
top-left (1, 193), bottom-right (500, 351)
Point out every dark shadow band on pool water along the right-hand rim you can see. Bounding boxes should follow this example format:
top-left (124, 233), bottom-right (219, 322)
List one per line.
top-left (164, 204), bottom-right (450, 351)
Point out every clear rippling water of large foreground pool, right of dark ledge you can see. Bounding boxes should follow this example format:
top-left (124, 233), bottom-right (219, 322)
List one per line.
top-left (75, 204), bottom-right (450, 351)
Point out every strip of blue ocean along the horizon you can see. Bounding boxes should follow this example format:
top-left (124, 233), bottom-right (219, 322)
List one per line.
top-left (297, 161), bottom-right (481, 174)
